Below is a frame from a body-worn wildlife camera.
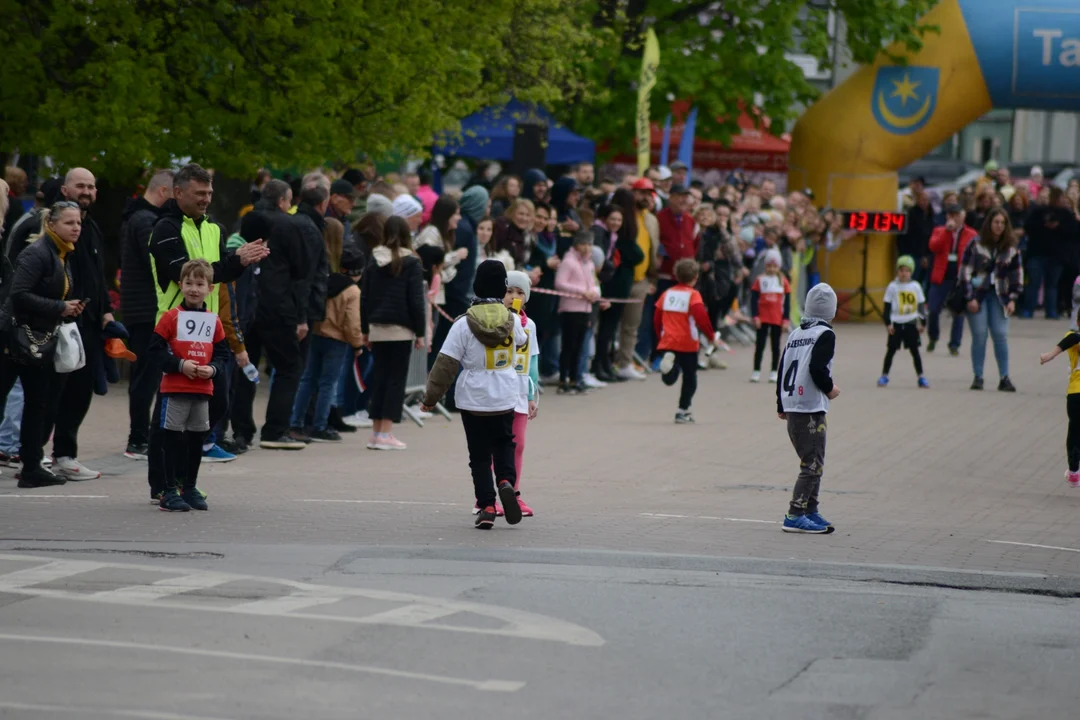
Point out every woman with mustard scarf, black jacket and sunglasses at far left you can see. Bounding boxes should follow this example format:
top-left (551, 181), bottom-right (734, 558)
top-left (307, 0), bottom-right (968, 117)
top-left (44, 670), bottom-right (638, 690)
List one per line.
top-left (0, 200), bottom-right (83, 488)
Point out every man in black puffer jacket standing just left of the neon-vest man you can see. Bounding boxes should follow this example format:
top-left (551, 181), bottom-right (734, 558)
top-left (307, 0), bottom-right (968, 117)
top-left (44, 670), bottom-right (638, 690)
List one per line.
top-left (120, 169), bottom-right (173, 460)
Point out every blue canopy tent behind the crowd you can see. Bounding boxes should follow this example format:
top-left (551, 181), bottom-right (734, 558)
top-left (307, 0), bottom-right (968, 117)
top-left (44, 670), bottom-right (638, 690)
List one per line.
top-left (434, 99), bottom-right (596, 165)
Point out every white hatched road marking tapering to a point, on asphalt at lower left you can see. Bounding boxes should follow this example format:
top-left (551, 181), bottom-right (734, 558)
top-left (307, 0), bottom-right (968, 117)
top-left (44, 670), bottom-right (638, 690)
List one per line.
top-left (0, 555), bottom-right (604, 648)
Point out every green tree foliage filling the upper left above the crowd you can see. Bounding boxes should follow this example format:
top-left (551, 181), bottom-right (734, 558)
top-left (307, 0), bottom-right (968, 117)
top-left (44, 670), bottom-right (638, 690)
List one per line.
top-left (0, 0), bottom-right (591, 181)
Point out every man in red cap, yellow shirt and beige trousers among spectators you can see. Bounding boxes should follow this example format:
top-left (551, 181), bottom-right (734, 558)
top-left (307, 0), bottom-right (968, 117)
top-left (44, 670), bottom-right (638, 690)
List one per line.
top-left (615, 177), bottom-right (660, 380)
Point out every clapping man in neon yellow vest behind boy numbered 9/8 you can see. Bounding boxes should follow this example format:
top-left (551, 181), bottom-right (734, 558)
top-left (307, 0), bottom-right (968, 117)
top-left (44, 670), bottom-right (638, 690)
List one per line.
top-left (147, 163), bottom-right (269, 498)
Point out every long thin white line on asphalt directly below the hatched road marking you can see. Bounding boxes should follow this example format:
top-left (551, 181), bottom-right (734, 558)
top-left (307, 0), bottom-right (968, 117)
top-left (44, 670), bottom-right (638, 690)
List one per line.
top-left (0, 633), bottom-right (525, 693)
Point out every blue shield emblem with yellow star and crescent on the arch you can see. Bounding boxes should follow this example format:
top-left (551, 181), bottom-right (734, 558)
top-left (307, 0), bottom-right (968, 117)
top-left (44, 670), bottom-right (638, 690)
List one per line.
top-left (870, 65), bottom-right (941, 135)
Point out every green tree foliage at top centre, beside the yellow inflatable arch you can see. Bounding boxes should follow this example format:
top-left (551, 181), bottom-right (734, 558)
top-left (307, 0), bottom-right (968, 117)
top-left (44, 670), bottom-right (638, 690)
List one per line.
top-left (566, 0), bottom-right (937, 150)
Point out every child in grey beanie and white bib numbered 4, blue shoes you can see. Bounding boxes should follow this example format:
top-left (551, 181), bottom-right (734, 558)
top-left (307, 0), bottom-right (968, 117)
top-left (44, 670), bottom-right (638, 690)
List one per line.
top-left (777, 283), bottom-right (840, 534)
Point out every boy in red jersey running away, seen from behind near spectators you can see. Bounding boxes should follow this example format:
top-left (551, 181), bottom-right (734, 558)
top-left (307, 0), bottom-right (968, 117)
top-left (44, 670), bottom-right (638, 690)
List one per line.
top-left (652, 258), bottom-right (714, 424)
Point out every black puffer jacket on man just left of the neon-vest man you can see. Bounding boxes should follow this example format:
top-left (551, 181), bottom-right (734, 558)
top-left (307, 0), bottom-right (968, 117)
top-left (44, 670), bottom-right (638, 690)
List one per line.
top-left (120, 198), bottom-right (161, 325)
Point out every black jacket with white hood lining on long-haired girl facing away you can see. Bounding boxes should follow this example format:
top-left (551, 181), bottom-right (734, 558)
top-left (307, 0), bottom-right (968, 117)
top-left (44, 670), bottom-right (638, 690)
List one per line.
top-left (360, 246), bottom-right (428, 338)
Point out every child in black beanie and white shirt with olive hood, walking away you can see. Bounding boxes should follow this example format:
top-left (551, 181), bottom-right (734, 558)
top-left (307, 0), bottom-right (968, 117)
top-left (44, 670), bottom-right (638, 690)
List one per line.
top-left (421, 260), bottom-right (528, 530)
